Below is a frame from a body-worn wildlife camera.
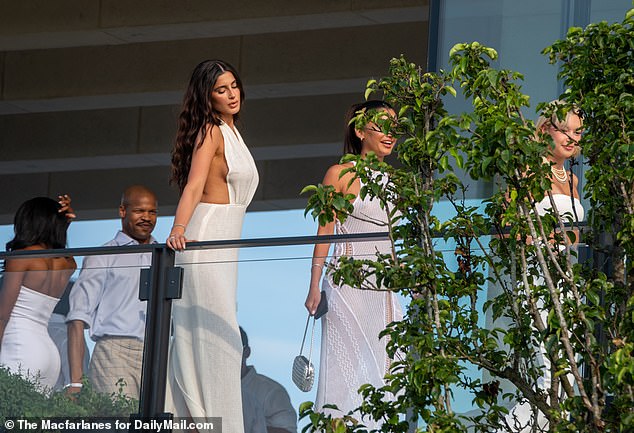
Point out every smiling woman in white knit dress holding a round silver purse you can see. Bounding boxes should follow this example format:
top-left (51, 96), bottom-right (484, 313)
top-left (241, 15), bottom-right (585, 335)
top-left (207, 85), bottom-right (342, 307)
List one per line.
top-left (306, 101), bottom-right (403, 427)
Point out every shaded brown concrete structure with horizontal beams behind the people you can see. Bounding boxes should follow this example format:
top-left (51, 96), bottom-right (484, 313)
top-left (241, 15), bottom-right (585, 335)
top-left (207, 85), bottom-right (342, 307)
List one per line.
top-left (0, 0), bottom-right (428, 223)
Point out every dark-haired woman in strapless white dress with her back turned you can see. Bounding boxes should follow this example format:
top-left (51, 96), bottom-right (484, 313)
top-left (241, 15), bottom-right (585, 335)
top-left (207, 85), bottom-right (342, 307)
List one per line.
top-left (0, 196), bottom-right (76, 390)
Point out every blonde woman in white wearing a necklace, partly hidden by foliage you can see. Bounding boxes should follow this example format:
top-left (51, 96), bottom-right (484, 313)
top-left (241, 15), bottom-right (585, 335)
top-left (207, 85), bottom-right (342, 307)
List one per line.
top-left (507, 101), bottom-right (585, 432)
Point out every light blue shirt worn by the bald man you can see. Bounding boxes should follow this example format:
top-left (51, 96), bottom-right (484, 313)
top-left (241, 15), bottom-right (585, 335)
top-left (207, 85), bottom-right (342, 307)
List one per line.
top-left (66, 231), bottom-right (156, 341)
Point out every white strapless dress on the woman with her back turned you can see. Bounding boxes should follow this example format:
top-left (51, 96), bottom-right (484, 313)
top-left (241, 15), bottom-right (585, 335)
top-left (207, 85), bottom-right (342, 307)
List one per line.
top-left (0, 286), bottom-right (61, 389)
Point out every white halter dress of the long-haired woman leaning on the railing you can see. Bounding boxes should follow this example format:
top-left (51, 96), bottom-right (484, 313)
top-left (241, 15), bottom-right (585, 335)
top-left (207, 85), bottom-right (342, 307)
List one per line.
top-left (165, 123), bottom-right (258, 433)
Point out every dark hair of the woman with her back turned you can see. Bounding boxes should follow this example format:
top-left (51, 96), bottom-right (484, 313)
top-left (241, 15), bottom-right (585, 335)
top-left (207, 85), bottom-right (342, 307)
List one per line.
top-left (6, 197), bottom-right (69, 251)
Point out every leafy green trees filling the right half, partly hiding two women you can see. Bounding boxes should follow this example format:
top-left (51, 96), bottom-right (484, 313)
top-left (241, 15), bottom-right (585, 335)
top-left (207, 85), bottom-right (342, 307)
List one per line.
top-left (300, 6), bottom-right (634, 432)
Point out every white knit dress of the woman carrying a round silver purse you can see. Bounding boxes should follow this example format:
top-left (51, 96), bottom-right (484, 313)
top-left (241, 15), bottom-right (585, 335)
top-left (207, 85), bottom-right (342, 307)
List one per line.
top-left (315, 173), bottom-right (403, 428)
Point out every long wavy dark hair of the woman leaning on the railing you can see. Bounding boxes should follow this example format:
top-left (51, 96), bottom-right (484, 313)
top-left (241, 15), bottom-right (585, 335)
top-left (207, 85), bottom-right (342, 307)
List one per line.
top-left (170, 60), bottom-right (244, 193)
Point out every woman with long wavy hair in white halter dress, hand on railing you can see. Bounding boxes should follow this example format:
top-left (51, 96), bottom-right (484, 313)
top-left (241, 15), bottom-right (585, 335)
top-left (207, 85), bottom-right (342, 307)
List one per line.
top-left (166, 60), bottom-right (258, 433)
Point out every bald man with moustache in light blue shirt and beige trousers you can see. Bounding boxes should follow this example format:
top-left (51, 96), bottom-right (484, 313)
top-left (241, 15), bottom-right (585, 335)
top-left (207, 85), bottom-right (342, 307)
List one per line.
top-left (66, 185), bottom-right (158, 399)
